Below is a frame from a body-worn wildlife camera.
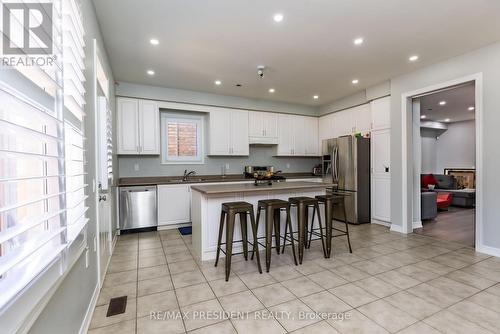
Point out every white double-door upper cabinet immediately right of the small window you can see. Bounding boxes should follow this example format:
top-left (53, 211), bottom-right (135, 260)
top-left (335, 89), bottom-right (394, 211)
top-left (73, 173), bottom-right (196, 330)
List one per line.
top-left (208, 110), bottom-right (249, 155)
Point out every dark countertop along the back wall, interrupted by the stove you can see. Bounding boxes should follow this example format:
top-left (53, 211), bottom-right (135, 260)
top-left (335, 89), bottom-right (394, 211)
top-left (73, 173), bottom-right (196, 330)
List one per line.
top-left (118, 173), bottom-right (322, 187)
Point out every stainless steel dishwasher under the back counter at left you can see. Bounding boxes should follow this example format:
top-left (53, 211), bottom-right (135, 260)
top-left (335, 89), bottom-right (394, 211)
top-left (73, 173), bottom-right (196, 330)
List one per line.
top-left (120, 186), bottom-right (158, 230)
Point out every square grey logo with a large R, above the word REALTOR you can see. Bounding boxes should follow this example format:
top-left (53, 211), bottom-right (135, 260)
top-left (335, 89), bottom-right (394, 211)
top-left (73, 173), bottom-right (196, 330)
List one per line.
top-left (2, 2), bottom-right (53, 55)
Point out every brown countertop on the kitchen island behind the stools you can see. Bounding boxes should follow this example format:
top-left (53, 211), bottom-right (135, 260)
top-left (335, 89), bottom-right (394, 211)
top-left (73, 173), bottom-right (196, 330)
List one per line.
top-left (191, 181), bottom-right (333, 195)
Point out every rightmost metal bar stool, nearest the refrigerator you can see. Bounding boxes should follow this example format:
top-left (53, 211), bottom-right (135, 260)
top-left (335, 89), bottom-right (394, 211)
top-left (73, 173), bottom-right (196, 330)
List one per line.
top-left (309, 190), bottom-right (352, 258)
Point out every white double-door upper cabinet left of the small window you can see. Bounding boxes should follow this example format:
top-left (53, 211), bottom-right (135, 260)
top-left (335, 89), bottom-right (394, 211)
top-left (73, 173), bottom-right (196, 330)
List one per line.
top-left (116, 97), bottom-right (160, 155)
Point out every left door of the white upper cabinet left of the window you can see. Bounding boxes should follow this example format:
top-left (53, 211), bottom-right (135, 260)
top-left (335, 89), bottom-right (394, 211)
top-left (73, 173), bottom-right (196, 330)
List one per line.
top-left (116, 98), bottom-right (139, 154)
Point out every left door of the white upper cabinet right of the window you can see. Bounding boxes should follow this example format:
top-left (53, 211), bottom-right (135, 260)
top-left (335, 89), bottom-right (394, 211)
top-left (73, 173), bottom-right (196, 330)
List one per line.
top-left (209, 111), bottom-right (231, 155)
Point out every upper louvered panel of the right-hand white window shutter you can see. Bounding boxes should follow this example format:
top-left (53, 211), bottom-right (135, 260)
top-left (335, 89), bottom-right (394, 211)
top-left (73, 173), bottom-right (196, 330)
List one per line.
top-left (62, 0), bottom-right (85, 121)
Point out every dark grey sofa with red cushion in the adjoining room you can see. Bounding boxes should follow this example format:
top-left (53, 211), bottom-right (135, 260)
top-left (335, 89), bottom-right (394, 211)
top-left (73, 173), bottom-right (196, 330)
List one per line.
top-left (420, 174), bottom-right (476, 208)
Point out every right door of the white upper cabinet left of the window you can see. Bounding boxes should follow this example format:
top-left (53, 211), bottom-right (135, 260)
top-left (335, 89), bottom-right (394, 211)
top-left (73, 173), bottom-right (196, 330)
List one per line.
top-left (139, 100), bottom-right (160, 154)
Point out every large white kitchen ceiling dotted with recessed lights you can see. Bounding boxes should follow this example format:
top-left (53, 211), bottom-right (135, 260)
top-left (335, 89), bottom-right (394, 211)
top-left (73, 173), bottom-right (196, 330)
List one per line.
top-left (94, 0), bottom-right (500, 105)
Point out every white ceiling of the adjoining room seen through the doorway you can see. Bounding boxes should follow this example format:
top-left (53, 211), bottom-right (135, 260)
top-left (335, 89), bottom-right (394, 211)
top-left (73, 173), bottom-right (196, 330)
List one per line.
top-left (420, 83), bottom-right (475, 123)
